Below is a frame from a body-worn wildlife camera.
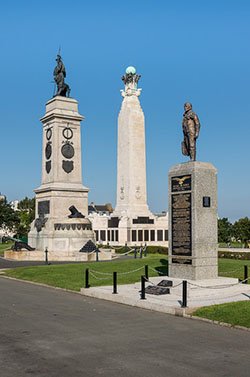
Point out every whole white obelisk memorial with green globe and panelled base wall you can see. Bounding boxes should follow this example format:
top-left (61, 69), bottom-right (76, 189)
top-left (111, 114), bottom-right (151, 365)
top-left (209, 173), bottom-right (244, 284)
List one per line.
top-left (92, 67), bottom-right (168, 246)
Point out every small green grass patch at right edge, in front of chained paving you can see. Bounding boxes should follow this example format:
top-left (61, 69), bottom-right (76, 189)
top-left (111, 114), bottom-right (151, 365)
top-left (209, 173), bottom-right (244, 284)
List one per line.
top-left (193, 300), bottom-right (250, 327)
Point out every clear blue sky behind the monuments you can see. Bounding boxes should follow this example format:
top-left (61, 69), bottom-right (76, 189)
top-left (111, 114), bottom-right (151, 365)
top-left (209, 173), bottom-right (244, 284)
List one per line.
top-left (0, 0), bottom-right (250, 220)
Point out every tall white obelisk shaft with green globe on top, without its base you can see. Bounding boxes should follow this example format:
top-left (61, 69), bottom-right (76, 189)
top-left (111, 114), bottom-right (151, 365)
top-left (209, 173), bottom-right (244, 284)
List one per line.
top-left (113, 67), bottom-right (152, 218)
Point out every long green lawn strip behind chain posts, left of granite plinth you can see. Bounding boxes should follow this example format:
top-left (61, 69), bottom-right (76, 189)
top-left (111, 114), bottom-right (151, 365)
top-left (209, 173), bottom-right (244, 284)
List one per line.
top-left (4, 254), bottom-right (168, 291)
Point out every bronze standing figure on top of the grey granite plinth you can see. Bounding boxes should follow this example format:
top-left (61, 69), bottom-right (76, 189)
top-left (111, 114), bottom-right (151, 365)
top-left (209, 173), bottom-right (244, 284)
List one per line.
top-left (181, 102), bottom-right (200, 161)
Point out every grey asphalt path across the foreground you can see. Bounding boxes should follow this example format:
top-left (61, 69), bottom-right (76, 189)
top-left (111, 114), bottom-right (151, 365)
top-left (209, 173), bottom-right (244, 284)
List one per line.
top-left (0, 277), bottom-right (250, 377)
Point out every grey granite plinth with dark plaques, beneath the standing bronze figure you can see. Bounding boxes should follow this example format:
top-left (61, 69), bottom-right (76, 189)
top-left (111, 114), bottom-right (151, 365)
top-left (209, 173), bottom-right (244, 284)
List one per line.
top-left (169, 161), bottom-right (218, 280)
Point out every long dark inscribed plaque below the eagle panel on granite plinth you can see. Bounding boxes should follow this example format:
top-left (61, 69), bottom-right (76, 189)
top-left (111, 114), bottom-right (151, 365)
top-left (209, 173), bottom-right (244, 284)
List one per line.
top-left (171, 193), bottom-right (192, 264)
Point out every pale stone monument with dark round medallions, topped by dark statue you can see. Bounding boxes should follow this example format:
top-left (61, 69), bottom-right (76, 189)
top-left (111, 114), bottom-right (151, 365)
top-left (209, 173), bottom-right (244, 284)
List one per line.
top-left (29, 55), bottom-right (94, 260)
